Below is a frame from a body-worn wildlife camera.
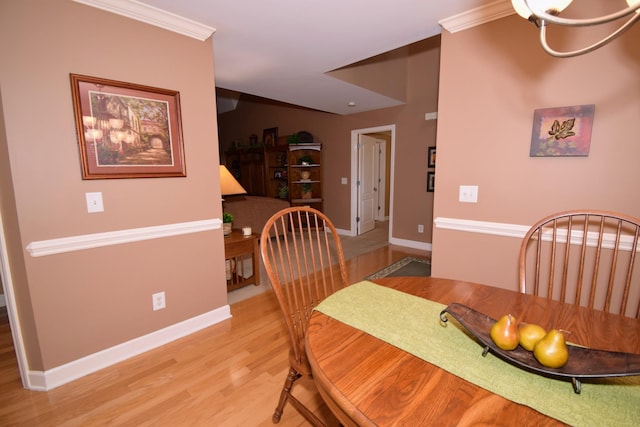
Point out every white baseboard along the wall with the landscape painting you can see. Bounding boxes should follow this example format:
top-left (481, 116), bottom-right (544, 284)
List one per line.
top-left (27, 305), bottom-right (231, 391)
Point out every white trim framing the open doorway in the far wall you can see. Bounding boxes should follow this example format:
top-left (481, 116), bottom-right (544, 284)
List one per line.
top-left (349, 125), bottom-right (396, 240)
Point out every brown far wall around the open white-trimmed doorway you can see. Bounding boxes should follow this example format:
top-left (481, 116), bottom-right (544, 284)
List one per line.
top-left (218, 37), bottom-right (440, 243)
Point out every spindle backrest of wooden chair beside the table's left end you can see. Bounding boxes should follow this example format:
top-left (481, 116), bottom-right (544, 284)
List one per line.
top-left (260, 206), bottom-right (348, 363)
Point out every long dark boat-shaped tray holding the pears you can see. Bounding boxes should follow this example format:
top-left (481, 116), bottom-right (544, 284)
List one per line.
top-left (440, 303), bottom-right (640, 393)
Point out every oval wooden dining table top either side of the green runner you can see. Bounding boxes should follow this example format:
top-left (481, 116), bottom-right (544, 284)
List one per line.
top-left (305, 277), bottom-right (640, 426)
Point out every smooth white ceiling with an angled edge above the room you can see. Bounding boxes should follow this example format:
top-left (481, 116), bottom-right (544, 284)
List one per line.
top-left (75, 0), bottom-right (513, 114)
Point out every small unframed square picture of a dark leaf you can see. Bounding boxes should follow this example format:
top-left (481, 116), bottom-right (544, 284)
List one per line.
top-left (529, 105), bottom-right (595, 157)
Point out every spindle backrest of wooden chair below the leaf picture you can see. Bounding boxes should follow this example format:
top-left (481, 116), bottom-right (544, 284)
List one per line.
top-left (519, 210), bottom-right (640, 318)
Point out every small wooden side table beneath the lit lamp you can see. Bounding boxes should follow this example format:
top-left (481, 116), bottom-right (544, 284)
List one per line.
top-left (224, 230), bottom-right (260, 291)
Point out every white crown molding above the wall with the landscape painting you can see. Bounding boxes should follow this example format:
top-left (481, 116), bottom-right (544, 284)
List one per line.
top-left (73, 0), bottom-right (216, 41)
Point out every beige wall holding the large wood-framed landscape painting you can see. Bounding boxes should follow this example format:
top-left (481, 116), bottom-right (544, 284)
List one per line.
top-left (0, 0), bottom-right (226, 370)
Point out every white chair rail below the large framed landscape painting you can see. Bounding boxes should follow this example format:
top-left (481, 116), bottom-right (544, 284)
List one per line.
top-left (27, 218), bottom-right (222, 257)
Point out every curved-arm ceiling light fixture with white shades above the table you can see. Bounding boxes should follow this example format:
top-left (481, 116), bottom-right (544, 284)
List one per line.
top-left (511, 0), bottom-right (640, 58)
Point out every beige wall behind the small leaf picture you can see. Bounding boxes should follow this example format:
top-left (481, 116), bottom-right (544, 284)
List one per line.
top-left (432, 11), bottom-right (640, 289)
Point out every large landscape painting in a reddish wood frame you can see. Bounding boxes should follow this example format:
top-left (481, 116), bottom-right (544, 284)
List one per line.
top-left (70, 74), bottom-right (186, 179)
